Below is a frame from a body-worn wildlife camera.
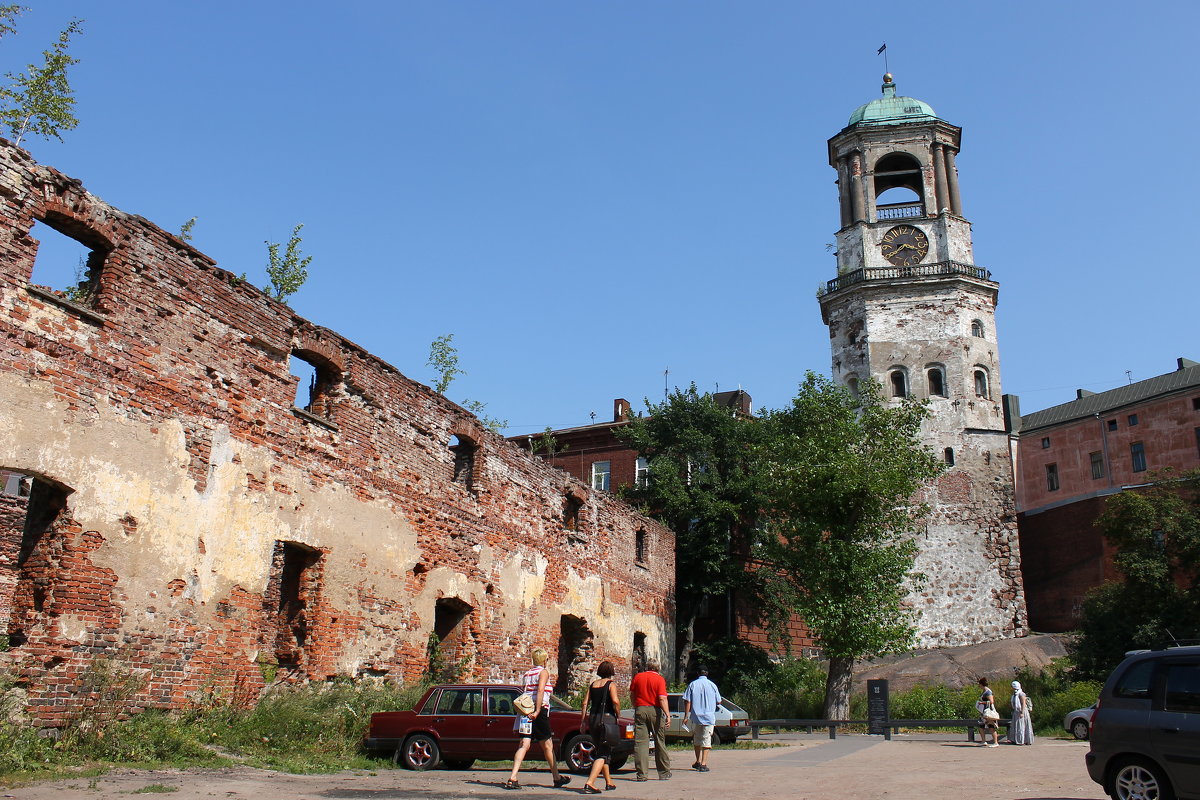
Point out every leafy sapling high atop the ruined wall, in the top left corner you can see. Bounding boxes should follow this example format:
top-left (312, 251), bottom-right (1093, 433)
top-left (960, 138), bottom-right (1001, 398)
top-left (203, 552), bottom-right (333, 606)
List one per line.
top-left (0, 16), bottom-right (83, 145)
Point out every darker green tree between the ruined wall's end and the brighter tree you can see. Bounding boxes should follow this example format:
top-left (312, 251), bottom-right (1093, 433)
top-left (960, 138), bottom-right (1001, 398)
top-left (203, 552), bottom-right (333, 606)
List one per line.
top-left (616, 384), bottom-right (767, 681)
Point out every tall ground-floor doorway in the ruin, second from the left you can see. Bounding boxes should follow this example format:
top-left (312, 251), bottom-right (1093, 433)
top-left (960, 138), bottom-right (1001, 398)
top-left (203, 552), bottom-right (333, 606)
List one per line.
top-left (264, 541), bottom-right (322, 668)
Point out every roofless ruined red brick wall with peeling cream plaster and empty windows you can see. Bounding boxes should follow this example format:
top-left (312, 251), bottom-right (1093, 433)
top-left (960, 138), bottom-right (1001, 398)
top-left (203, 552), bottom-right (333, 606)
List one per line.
top-left (0, 143), bottom-right (674, 724)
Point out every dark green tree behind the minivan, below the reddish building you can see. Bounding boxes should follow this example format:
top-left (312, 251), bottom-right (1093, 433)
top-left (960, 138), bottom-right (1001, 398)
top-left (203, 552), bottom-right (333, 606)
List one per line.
top-left (1073, 470), bottom-right (1200, 679)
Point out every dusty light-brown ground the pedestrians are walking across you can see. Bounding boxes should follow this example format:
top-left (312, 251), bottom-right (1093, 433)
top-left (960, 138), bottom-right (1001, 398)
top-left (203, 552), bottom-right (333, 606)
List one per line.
top-left (0, 734), bottom-right (1104, 800)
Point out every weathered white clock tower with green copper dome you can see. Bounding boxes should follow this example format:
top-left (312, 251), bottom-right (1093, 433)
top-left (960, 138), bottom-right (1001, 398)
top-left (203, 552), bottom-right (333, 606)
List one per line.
top-left (820, 74), bottom-right (1027, 646)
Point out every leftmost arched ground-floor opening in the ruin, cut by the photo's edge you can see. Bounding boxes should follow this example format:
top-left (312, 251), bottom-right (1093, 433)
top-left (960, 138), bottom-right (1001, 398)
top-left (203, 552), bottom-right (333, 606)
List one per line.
top-left (0, 470), bottom-right (73, 646)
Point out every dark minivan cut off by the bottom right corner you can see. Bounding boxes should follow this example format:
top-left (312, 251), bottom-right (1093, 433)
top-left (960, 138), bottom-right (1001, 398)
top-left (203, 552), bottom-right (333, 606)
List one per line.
top-left (1086, 646), bottom-right (1200, 800)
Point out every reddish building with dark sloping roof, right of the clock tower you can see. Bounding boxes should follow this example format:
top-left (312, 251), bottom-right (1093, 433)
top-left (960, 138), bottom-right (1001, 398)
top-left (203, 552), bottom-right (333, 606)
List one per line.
top-left (1010, 359), bottom-right (1200, 632)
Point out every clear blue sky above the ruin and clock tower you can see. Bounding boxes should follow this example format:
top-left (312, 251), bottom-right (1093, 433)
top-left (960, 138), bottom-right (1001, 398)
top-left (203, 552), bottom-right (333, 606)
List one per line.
top-left (18, 0), bottom-right (1200, 434)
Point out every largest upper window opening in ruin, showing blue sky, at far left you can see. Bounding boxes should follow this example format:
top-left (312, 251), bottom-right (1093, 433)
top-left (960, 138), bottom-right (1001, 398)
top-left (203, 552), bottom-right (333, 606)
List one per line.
top-left (29, 216), bottom-right (108, 306)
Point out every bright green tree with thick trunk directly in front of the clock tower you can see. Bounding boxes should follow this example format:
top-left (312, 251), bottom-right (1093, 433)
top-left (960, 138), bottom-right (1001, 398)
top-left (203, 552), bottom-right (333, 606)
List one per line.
top-left (761, 372), bottom-right (942, 720)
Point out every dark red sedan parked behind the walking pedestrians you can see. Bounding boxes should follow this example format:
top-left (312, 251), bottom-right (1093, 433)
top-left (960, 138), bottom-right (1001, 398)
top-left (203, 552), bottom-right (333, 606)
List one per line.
top-left (362, 684), bottom-right (634, 772)
